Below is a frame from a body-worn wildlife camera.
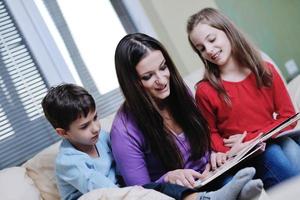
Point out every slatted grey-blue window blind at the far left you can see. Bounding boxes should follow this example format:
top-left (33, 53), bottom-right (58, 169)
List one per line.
top-left (0, 0), bottom-right (59, 169)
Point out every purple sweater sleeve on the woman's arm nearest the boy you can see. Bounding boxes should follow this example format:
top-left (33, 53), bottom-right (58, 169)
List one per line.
top-left (111, 113), bottom-right (164, 186)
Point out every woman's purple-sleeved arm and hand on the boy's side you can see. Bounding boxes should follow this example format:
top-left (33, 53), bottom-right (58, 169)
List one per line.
top-left (111, 114), bottom-right (203, 187)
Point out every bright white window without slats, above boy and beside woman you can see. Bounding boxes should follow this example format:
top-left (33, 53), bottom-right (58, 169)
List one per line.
top-left (34, 0), bottom-right (135, 117)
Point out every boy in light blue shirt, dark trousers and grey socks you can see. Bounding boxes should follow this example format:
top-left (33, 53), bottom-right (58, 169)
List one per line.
top-left (42, 84), bottom-right (262, 200)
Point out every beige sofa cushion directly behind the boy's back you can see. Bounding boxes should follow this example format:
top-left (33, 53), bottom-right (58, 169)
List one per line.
top-left (23, 142), bottom-right (60, 200)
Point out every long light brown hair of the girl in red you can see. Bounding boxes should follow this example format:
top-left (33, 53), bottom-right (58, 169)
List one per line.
top-left (187, 8), bottom-right (272, 103)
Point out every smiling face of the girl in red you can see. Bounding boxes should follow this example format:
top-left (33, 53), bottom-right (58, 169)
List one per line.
top-left (189, 23), bottom-right (232, 66)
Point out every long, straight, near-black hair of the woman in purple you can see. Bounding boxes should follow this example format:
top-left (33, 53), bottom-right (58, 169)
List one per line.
top-left (115, 33), bottom-right (210, 170)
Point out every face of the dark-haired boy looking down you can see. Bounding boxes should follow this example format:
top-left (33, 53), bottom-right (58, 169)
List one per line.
top-left (64, 111), bottom-right (100, 149)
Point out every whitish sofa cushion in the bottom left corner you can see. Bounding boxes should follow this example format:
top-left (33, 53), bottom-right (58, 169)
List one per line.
top-left (0, 167), bottom-right (40, 200)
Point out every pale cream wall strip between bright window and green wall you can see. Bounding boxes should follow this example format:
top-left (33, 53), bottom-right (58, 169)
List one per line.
top-left (140, 0), bottom-right (217, 76)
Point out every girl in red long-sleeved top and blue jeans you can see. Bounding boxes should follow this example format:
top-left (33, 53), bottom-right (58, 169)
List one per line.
top-left (187, 8), bottom-right (300, 188)
